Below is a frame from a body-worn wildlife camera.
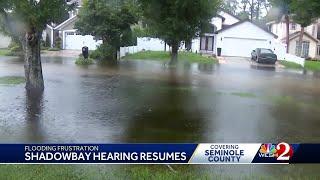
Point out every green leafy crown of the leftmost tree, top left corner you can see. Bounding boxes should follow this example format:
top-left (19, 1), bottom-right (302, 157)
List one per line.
top-left (0, 0), bottom-right (74, 34)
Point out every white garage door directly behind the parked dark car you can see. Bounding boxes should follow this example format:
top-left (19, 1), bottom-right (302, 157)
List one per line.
top-left (221, 37), bottom-right (270, 57)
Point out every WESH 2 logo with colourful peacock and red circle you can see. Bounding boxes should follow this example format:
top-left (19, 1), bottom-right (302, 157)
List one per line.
top-left (259, 143), bottom-right (293, 161)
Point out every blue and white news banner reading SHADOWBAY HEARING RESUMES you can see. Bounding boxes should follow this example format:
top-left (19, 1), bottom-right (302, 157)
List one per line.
top-left (0, 142), bottom-right (320, 164)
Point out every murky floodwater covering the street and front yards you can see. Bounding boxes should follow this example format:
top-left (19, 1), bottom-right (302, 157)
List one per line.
top-left (0, 57), bottom-right (320, 177)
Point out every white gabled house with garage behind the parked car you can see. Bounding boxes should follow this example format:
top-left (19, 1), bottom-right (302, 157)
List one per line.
top-left (193, 11), bottom-right (279, 57)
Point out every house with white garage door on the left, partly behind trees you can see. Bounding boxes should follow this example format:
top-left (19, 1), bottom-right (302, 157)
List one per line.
top-left (43, 0), bottom-right (102, 50)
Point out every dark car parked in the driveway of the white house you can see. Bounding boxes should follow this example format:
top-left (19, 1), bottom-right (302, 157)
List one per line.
top-left (251, 48), bottom-right (277, 64)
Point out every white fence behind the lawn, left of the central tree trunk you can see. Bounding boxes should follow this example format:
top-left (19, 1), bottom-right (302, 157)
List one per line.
top-left (120, 37), bottom-right (170, 58)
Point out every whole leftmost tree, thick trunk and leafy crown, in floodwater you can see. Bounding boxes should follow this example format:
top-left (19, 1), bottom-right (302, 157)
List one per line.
top-left (0, 0), bottom-right (74, 91)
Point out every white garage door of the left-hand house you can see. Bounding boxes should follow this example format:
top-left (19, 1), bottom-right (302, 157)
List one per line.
top-left (64, 32), bottom-right (102, 50)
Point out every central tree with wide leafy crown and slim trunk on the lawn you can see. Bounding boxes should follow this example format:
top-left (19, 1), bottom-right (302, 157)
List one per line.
top-left (139, 0), bottom-right (221, 63)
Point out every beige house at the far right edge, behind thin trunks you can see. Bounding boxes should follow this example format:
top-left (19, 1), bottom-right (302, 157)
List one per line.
top-left (267, 19), bottom-right (320, 58)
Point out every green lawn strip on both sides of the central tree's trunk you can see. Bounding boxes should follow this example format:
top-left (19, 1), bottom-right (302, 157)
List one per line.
top-left (123, 51), bottom-right (217, 63)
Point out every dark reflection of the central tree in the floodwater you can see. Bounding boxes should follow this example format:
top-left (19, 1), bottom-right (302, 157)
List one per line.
top-left (125, 69), bottom-right (206, 143)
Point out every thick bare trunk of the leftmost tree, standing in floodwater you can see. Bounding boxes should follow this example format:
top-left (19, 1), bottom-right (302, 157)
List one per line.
top-left (23, 31), bottom-right (44, 91)
